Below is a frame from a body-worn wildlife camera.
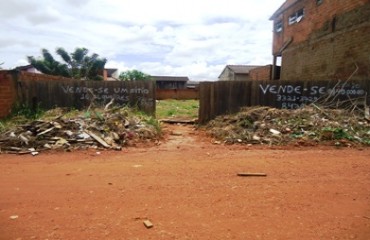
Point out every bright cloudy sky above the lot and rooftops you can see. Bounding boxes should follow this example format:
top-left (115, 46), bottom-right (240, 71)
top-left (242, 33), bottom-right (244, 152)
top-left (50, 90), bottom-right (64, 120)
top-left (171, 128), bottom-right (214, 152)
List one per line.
top-left (0, 0), bottom-right (285, 81)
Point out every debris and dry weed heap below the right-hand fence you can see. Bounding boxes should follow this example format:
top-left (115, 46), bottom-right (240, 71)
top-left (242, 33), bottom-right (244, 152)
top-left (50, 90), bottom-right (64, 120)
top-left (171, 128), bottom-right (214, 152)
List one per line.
top-left (206, 105), bottom-right (370, 146)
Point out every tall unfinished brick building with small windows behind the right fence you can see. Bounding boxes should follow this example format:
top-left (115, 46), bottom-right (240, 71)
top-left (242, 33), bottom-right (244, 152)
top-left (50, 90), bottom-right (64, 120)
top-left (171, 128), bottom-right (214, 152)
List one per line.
top-left (270, 0), bottom-right (370, 80)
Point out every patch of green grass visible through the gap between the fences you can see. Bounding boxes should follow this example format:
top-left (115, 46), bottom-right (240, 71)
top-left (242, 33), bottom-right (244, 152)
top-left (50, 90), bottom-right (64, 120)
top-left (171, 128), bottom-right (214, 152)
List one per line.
top-left (156, 99), bottom-right (199, 119)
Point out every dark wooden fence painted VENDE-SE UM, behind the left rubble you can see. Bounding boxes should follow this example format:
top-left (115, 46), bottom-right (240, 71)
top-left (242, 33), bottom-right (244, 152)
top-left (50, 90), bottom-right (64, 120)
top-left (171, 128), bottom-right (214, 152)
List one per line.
top-left (17, 71), bottom-right (156, 115)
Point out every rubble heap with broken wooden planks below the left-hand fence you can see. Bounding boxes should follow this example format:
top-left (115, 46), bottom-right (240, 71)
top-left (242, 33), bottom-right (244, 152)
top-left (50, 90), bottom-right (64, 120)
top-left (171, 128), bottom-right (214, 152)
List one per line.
top-left (0, 108), bottom-right (160, 155)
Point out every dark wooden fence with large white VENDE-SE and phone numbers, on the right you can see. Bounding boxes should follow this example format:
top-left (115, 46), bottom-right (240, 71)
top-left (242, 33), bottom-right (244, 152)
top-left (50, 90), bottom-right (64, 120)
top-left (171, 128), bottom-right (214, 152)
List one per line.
top-left (199, 80), bottom-right (370, 124)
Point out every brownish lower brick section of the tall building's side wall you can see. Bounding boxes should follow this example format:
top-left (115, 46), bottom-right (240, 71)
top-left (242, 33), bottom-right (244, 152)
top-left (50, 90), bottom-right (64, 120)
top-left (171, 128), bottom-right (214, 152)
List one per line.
top-left (281, 24), bottom-right (370, 81)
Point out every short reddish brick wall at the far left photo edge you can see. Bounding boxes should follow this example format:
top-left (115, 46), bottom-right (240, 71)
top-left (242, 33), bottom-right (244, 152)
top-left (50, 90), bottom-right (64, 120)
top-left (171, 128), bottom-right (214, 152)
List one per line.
top-left (0, 71), bottom-right (17, 118)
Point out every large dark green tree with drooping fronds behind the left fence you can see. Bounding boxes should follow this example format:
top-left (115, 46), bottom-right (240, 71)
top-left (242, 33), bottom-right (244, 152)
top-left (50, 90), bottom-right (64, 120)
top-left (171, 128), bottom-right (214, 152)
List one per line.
top-left (27, 48), bottom-right (107, 80)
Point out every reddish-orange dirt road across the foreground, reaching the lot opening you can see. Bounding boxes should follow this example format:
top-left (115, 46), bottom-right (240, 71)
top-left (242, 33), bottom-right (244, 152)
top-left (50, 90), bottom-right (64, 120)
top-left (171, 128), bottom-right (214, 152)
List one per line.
top-left (0, 126), bottom-right (370, 240)
